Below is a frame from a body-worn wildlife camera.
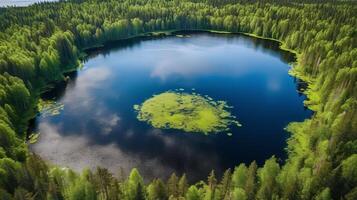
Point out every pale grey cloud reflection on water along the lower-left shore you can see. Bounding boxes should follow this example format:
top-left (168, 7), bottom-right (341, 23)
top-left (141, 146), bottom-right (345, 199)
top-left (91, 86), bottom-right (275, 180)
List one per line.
top-left (31, 123), bottom-right (170, 179)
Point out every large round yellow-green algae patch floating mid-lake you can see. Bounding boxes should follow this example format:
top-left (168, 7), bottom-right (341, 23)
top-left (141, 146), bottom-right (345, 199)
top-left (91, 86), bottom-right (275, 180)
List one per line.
top-left (134, 89), bottom-right (241, 135)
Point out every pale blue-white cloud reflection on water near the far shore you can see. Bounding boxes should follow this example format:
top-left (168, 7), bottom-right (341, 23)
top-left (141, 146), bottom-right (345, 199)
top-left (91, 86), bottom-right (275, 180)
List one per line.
top-left (151, 43), bottom-right (279, 81)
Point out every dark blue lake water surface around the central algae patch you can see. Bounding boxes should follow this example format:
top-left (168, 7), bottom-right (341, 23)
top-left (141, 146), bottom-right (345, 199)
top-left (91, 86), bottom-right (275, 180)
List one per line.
top-left (31, 33), bottom-right (311, 181)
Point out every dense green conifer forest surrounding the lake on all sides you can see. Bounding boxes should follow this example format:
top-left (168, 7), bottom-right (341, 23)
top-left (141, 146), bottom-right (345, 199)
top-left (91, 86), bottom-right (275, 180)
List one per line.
top-left (0, 0), bottom-right (357, 200)
